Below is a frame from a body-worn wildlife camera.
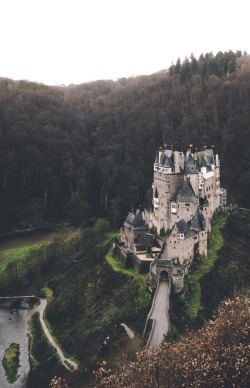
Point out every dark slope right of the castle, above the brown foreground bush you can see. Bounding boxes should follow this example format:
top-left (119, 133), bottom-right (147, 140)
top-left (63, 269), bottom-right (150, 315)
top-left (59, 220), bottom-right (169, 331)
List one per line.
top-left (201, 210), bottom-right (250, 318)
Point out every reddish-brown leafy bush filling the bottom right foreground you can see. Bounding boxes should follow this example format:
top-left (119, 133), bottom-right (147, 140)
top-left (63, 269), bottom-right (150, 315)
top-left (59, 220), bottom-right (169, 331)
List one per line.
top-left (96, 295), bottom-right (250, 388)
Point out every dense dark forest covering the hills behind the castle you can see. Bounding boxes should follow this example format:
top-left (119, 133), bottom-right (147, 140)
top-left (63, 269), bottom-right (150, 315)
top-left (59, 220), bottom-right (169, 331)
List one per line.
top-left (0, 51), bottom-right (250, 232)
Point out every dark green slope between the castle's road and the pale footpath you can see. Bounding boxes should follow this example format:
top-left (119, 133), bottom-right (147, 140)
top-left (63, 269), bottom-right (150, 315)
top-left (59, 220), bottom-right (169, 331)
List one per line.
top-left (43, 242), bottom-right (150, 386)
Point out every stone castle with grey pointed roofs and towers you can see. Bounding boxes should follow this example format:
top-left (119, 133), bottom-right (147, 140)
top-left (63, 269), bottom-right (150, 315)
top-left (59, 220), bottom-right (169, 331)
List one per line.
top-left (117, 146), bottom-right (226, 292)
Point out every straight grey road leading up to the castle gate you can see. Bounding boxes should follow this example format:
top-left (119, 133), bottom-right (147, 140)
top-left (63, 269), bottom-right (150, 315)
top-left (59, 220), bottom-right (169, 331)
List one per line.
top-left (147, 280), bottom-right (169, 351)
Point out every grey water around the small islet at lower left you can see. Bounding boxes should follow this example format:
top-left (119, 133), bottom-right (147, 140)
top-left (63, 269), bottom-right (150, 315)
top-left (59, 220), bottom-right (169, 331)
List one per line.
top-left (0, 309), bottom-right (30, 388)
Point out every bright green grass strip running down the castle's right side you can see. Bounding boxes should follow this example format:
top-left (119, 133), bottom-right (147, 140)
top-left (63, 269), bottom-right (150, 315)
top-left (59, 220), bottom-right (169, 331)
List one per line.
top-left (186, 214), bottom-right (228, 320)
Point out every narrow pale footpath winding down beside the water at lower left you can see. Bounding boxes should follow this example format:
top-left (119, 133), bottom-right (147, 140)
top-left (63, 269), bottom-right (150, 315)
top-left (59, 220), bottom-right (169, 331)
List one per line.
top-left (27, 299), bottom-right (78, 372)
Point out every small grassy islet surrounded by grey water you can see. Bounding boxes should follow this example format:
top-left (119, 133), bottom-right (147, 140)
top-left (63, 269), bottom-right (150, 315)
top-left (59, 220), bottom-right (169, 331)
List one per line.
top-left (2, 343), bottom-right (20, 384)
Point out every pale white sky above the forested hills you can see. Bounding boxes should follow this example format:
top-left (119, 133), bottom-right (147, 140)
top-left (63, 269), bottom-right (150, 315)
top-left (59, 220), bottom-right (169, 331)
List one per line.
top-left (0, 0), bottom-right (250, 85)
